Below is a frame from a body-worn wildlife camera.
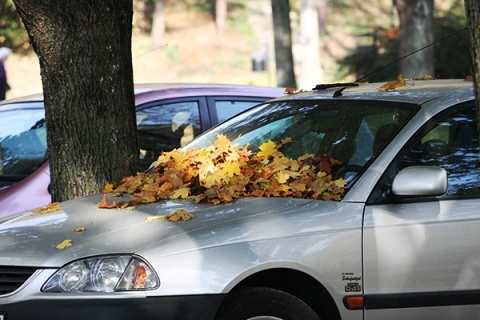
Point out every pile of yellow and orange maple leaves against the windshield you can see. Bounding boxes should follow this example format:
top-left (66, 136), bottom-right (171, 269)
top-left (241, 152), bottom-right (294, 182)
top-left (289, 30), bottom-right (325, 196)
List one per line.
top-left (97, 135), bottom-right (346, 208)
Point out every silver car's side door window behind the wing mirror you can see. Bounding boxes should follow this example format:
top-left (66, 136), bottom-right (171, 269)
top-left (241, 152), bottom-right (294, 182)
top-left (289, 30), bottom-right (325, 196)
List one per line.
top-left (398, 107), bottom-right (480, 197)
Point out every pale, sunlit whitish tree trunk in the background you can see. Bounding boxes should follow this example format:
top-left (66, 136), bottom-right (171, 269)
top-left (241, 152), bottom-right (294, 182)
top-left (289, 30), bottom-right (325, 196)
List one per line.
top-left (300, 0), bottom-right (323, 90)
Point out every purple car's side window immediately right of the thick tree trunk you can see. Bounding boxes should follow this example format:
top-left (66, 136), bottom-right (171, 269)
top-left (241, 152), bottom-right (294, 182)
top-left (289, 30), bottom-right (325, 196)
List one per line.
top-left (137, 101), bottom-right (202, 169)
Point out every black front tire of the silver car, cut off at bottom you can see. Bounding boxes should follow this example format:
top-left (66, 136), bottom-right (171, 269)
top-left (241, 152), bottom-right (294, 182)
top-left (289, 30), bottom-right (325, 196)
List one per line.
top-left (216, 287), bottom-right (320, 320)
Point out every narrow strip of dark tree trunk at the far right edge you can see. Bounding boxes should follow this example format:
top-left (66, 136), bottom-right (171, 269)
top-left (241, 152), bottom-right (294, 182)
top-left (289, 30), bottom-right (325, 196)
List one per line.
top-left (465, 0), bottom-right (480, 127)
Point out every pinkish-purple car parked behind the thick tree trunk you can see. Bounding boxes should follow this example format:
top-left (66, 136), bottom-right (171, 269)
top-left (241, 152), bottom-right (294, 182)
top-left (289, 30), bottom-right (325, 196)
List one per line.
top-left (0, 84), bottom-right (285, 217)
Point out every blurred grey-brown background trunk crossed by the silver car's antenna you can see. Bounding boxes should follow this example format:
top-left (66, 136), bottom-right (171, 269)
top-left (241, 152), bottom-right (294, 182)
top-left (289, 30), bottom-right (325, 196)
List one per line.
top-left (396, 0), bottom-right (435, 78)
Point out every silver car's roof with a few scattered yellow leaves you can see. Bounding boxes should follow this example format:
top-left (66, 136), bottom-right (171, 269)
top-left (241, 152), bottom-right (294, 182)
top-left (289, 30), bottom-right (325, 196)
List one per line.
top-left (277, 79), bottom-right (473, 105)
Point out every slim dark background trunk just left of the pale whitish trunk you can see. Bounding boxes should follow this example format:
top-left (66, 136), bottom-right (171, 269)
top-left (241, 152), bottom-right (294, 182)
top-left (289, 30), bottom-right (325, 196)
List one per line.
top-left (272, 0), bottom-right (297, 88)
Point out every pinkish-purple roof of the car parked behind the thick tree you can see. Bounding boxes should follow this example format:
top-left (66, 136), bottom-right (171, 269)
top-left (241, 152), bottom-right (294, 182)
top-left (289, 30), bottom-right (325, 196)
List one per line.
top-left (0, 83), bottom-right (285, 106)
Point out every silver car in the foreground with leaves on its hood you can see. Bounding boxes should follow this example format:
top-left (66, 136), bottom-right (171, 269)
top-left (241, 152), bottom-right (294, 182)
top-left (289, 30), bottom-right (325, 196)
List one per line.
top-left (0, 80), bottom-right (480, 320)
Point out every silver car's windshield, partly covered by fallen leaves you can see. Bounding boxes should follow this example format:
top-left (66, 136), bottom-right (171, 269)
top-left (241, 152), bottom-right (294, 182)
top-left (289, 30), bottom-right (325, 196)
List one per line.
top-left (184, 100), bottom-right (419, 188)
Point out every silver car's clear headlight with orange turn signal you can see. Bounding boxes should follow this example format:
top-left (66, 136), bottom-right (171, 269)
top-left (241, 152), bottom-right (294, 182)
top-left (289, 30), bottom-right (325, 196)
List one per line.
top-left (42, 256), bottom-right (160, 293)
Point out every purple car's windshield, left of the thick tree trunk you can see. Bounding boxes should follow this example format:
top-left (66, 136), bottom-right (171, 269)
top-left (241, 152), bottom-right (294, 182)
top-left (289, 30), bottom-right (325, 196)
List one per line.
top-left (0, 102), bottom-right (47, 186)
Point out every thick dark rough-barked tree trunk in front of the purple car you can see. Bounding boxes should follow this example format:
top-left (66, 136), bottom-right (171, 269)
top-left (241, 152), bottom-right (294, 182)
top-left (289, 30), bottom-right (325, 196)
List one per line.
top-left (14, 0), bottom-right (138, 201)
